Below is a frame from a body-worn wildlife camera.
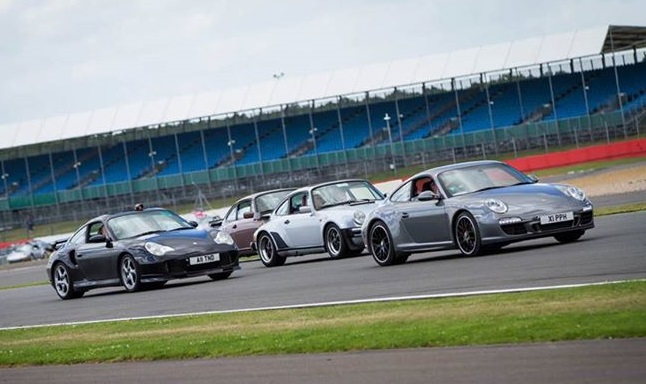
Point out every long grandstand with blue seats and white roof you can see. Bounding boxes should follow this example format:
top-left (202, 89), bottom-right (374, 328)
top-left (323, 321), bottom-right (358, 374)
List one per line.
top-left (0, 26), bottom-right (646, 227)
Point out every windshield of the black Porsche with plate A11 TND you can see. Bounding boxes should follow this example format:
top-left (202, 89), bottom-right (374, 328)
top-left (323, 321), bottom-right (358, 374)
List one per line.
top-left (108, 210), bottom-right (193, 240)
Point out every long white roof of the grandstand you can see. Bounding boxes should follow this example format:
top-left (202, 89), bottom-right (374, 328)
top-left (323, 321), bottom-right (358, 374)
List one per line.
top-left (0, 25), bottom-right (646, 149)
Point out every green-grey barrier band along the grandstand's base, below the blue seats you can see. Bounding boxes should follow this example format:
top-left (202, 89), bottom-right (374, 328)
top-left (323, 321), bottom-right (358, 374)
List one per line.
top-left (0, 106), bottom-right (641, 225)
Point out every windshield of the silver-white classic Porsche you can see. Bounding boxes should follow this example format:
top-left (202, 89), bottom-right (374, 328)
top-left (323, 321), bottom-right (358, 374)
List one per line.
top-left (312, 181), bottom-right (383, 209)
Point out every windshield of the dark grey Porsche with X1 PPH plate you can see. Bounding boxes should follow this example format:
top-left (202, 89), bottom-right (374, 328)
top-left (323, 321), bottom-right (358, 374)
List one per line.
top-left (438, 163), bottom-right (533, 197)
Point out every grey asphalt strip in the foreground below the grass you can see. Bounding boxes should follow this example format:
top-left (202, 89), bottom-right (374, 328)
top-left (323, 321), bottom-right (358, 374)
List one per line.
top-left (5, 339), bottom-right (646, 384)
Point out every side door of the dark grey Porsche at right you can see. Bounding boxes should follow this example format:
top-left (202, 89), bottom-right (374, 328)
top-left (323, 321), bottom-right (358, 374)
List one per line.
top-left (393, 181), bottom-right (450, 244)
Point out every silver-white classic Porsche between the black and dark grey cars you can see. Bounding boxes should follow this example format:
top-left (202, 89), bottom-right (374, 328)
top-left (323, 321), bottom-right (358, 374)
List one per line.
top-left (253, 179), bottom-right (384, 267)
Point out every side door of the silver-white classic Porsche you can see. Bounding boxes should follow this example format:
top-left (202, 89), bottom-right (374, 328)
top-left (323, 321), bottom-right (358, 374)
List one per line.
top-left (279, 192), bottom-right (323, 248)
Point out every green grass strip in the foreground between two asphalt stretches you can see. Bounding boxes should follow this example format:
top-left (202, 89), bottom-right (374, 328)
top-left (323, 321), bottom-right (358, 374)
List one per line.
top-left (0, 281), bottom-right (646, 366)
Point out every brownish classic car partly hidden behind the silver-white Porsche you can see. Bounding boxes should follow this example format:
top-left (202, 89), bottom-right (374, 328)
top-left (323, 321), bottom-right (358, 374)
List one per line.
top-left (211, 188), bottom-right (296, 255)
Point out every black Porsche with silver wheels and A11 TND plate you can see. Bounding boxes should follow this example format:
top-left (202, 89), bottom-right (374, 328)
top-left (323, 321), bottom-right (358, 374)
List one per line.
top-left (47, 208), bottom-right (239, 300)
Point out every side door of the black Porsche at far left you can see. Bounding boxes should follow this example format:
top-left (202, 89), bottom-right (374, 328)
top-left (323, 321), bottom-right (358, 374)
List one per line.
top-left (75, 221), bottom-right (120, 280)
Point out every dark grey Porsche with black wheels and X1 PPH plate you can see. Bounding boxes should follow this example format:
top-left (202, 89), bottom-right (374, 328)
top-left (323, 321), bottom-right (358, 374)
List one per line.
top-left (361, 160), bottom-right (594, 266)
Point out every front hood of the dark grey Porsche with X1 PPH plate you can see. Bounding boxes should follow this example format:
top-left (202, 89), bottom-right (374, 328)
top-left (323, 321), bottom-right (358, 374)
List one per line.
top-left (453, 183), bottom-right (588, 214)
